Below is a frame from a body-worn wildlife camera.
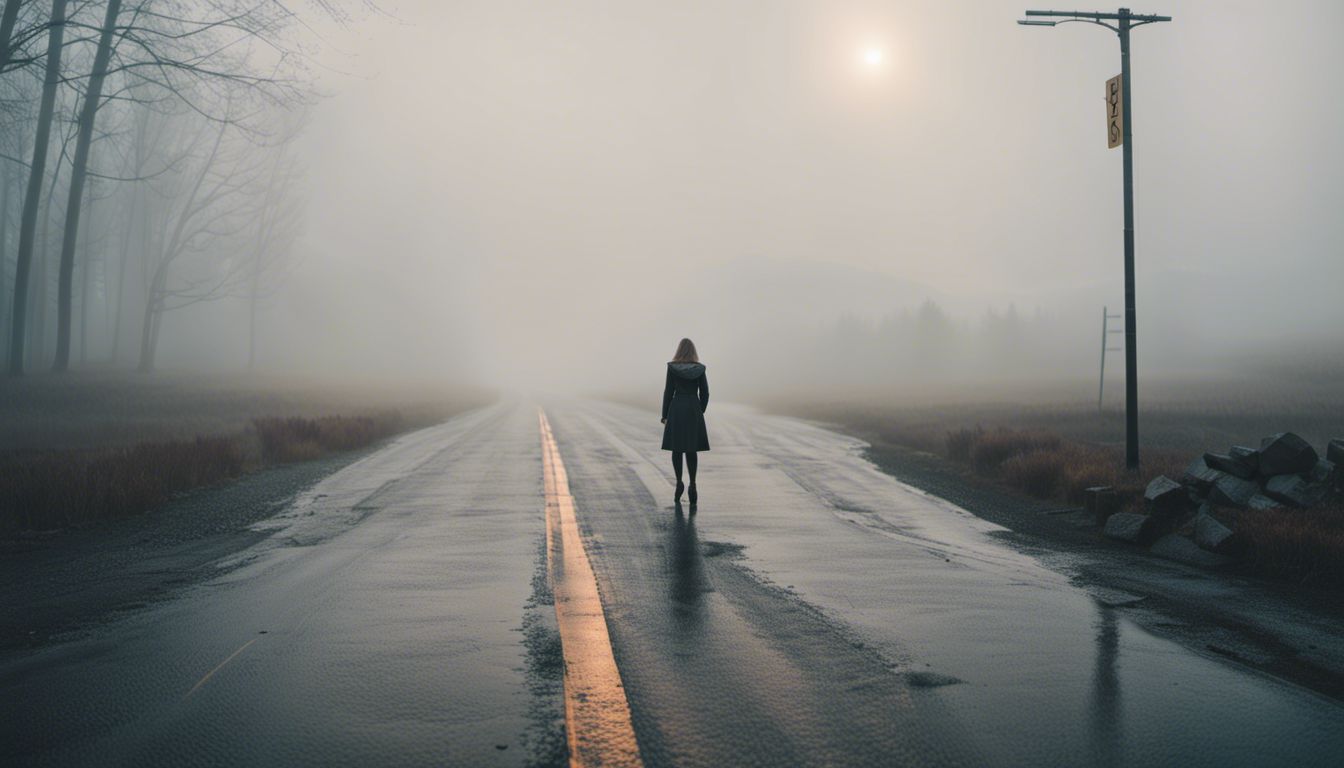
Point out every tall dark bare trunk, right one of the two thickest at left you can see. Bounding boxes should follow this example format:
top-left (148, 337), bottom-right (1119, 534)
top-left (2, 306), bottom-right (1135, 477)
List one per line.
top-left (52, 0), bottom-right (121, 371)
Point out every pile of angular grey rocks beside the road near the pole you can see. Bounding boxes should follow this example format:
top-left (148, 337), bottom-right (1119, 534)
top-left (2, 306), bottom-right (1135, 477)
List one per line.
top-left (1087, 432), bottom-right (1344, 565)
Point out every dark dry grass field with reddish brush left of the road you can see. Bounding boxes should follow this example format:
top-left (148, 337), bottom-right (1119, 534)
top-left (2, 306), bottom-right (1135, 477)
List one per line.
top-left (0, 374), bottom-right (491, 531)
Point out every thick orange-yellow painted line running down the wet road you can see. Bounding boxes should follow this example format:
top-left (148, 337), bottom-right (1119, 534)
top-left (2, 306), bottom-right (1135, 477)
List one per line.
top-left (538, 409), bottom-right (644, 768)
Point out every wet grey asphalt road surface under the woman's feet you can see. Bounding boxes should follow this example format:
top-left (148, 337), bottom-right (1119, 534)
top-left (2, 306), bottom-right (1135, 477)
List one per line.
top-left (0, 399), bottom-right (1344, 765)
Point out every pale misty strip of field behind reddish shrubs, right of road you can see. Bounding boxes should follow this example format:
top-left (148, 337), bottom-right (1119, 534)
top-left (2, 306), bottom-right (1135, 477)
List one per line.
top-left (755, 368), bottom-right (1344, 463)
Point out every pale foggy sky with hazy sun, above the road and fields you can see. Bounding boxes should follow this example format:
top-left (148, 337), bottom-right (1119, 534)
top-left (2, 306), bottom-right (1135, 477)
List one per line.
top-left (0, 0), bottom-right (1344, 399)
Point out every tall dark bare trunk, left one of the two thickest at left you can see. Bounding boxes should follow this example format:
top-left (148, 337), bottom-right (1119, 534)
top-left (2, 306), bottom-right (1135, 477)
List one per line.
top-left (9, 0), bottom-right (66, 375)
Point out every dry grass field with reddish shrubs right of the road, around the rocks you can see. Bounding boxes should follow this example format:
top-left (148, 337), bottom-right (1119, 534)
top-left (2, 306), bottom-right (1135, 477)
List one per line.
top-left (761, 366), bottom-right (1344, 589)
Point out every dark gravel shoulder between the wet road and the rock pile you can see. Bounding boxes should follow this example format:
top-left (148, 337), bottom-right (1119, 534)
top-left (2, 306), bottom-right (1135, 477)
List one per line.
top-left (854, 438), bottom-right (1344, 701)
